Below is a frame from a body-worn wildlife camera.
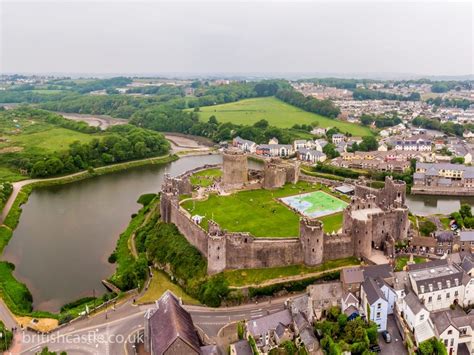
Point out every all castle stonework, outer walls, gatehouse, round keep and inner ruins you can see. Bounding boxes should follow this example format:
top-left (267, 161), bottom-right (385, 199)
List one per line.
top-left (160, 152), bottom-right (409, 274)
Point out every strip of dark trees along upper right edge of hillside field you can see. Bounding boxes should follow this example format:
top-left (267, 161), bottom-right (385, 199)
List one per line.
top-left (275, 90), bottom-right (341, 118)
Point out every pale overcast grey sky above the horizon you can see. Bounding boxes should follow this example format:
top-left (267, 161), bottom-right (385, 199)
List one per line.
top-left (0, 0), bottom-right (474, 75)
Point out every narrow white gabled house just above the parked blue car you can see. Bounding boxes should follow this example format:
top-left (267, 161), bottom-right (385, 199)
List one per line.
top-left (360, 277), bottom-right (388, 332)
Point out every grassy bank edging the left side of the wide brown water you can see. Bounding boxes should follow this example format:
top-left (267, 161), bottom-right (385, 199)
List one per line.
top-left (0, 155), bottom-right (178, 321)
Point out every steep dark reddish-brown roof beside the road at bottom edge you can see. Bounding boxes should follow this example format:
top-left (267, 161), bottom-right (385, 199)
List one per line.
top-left (149, 291), bottom-right (201, 354)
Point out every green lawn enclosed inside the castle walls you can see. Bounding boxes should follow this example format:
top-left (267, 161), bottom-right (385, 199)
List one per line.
top-left (182, 181), bottom-right (342, 238)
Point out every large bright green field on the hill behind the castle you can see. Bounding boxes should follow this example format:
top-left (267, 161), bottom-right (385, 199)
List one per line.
top-left (194, 97), bottom-right (372, 136)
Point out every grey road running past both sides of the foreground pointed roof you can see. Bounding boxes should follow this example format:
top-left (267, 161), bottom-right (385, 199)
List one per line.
top-left (13, 297), bottom-right (287, 355)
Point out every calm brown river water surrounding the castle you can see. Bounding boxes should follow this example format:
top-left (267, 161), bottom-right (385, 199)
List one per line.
top-left (3, 155), bottom-right (474, 311)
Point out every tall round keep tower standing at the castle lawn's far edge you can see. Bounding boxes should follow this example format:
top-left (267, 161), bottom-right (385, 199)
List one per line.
top-left (222, 150), bottom-right (248, 186)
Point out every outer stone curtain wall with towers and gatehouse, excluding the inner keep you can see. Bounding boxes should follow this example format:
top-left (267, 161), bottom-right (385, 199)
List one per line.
top-left (160, 166), bottom-right (408, 274)
